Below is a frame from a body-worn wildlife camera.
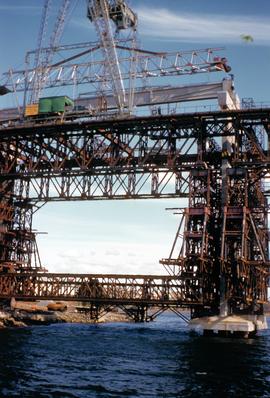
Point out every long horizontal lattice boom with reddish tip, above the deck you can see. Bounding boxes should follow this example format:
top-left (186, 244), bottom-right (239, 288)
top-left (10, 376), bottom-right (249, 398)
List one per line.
top-left (1, 43), bottom-right (230, 96)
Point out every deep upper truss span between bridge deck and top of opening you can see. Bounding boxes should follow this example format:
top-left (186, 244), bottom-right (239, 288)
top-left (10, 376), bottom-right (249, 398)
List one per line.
top-left (0, 109), bottom-right (270, 201)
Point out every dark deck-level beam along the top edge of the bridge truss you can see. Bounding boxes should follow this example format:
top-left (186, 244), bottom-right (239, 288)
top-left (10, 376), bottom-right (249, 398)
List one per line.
top-left (0, 108), bottom-right (270, 138)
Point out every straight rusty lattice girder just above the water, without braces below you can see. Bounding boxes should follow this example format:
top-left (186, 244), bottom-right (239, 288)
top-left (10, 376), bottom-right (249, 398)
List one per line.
top-left (0, 273), bottom-right (202, 306)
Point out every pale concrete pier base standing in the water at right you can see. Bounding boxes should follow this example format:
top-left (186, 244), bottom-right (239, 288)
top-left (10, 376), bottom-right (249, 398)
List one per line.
top-left (189, 315), bottom-right (268, 337)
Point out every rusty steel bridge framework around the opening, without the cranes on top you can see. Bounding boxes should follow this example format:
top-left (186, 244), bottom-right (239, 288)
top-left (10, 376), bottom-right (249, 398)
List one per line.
top-left (0, 109), bottom-right (270, 317)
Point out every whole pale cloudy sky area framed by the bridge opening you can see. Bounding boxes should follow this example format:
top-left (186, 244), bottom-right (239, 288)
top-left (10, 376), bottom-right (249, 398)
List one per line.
top-left (34, 199), bottom-right (182, 274)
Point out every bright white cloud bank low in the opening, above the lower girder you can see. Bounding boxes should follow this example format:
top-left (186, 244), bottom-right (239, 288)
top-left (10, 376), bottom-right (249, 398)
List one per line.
top-left (40, 241), bottom-right (170, 274)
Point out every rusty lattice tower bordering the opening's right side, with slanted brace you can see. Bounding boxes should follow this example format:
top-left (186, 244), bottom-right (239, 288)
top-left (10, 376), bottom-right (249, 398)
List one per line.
top-left (160, 167), bottom-right (221, 311)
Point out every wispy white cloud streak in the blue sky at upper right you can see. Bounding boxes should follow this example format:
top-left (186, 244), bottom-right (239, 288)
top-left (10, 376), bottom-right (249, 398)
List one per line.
top-left (137, 7), bottom-right (270, 44)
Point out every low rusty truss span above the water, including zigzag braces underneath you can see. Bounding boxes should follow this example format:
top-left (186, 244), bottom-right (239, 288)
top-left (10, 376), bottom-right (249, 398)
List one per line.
top-left (0, 273), bottom-right (196, 322)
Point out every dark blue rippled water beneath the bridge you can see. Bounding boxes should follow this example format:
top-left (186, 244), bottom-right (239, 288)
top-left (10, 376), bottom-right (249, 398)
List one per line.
top-left (0, 314), bottom-right (270, 398)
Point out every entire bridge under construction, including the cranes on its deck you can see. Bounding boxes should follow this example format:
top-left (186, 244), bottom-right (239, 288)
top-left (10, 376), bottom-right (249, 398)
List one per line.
top-left (0, 0), bottom-right (270, 333)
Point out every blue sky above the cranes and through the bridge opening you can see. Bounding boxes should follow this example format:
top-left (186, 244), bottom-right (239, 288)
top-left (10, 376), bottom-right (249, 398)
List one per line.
top-left (0, 0), bottom-right (270, 273)
